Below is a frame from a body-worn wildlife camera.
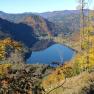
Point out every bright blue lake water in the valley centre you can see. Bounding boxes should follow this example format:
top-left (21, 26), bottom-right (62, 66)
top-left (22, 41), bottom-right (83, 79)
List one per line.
top-left (27, 44), bottom-right (75, 64)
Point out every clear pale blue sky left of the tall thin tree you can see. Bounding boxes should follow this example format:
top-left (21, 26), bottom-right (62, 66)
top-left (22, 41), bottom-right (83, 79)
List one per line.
top-left (0, 0), bottom-right (94, 13)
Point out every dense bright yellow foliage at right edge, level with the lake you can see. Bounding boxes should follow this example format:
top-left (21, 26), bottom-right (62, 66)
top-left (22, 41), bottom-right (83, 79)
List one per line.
top-left (75, 48), bottom-right (94, 70)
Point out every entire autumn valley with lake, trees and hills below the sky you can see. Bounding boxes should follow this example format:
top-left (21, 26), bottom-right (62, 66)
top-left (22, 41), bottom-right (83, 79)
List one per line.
top-left (0, 4), bottom-right (94, 94)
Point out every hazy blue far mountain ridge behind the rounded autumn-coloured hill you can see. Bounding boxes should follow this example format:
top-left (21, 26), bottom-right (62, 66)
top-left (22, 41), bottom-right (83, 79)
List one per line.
top-left (0, 10), bottom-right (80, 34)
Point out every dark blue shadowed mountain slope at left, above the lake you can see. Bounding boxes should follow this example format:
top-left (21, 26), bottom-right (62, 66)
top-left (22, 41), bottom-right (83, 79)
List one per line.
top-left (0, 18), bottom-right (38, 47)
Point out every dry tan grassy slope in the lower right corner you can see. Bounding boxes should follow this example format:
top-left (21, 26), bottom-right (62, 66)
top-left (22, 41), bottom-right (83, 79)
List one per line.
top-left (42, 72), bottom-right (94, 94)
